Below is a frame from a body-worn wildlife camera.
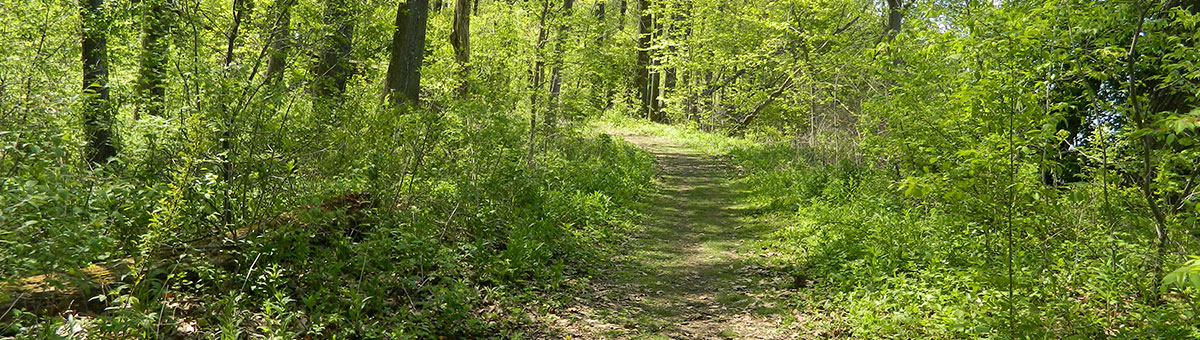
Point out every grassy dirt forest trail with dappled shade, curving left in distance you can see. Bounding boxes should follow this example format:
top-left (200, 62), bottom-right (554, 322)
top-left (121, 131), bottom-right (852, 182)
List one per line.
top-left (546, 132), bottom-right (798, 339)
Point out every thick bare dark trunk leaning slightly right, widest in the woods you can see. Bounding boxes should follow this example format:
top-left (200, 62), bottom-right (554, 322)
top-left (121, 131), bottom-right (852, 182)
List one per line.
top-left (384, 0), bottom-right (430, 107)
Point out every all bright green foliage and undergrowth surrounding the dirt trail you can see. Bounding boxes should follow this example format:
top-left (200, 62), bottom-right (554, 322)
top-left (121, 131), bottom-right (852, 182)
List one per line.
top-left (0, 0), bottom-right (1200, 339)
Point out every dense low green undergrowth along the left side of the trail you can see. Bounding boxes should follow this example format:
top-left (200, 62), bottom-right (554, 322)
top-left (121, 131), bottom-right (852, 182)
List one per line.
top-left (0, 103), bottom-right (653, 339)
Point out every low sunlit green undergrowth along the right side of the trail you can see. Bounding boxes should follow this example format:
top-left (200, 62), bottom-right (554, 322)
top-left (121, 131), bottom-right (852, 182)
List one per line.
top-left (609, 120), bottom-right (1198, 339)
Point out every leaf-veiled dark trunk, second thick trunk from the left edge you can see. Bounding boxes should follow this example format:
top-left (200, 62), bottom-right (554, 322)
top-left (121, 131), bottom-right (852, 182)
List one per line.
top-left (134, 0), bottom-right (172, 119)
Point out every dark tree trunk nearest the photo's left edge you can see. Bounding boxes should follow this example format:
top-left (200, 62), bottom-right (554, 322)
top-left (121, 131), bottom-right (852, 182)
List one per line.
top-left (79, 0), bottom-right (116, 165)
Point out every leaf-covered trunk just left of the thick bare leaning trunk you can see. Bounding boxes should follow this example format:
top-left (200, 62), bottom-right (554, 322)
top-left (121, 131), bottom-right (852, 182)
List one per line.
top-left (313, 0), bottom-right (354, 103)
